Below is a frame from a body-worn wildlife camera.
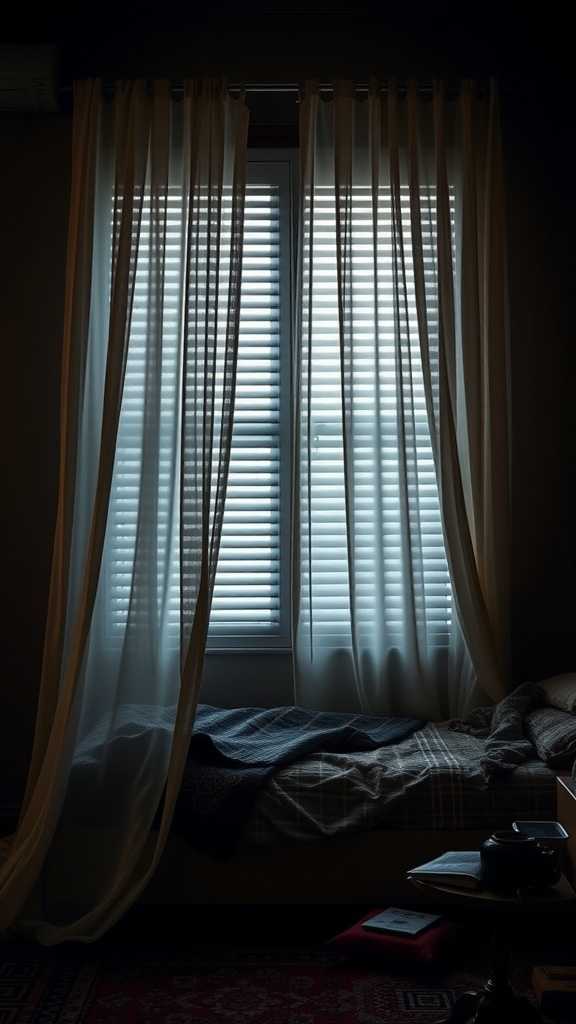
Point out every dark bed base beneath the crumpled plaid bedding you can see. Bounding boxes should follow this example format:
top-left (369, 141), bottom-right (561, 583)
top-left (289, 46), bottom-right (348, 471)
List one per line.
top-left (41, 827), bottom-right (489, 914)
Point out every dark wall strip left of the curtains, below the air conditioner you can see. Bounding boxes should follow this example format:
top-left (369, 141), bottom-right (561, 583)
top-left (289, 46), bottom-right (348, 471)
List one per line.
top-left (0, 116), bottom-right (71, 781)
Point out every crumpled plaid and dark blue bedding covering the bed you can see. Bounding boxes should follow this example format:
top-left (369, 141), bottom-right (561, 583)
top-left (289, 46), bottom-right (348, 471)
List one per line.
top-left (66, 683), bottom-right (556, 853)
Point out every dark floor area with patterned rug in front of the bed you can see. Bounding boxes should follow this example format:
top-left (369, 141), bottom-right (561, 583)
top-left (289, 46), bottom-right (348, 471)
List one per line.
top-left (0, 905), bottom-right (576, 1024)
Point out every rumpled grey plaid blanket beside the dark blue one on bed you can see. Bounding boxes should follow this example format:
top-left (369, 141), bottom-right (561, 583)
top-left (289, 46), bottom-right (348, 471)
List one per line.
top-left (244, 723), bottom-right (556, 846)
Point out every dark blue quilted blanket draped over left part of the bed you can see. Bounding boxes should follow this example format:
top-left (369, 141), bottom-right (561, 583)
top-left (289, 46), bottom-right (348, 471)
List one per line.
top-left (68, 705), bottom-right (424, 856)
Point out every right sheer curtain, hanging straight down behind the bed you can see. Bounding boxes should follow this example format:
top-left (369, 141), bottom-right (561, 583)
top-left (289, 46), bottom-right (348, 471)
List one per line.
top-left (293, 83), bottom-right (508, 719)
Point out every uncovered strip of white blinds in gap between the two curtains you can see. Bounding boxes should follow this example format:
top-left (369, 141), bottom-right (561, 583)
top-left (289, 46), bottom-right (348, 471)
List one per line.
top-left (210, 162), bottom-right (290, 638)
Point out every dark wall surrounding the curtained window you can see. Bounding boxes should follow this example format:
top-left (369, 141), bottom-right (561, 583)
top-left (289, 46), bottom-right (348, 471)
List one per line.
top-left (0, 5), bottom-right (576, 777)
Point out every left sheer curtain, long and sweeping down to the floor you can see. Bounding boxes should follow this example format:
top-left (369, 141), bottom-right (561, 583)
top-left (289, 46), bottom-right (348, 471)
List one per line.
top-left (0, 81), bottom-right (247, 943)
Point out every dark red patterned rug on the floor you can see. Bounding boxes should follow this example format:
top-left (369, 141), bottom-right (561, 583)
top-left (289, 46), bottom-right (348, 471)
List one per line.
top-left (0, 946), bottom-right (485, 1024)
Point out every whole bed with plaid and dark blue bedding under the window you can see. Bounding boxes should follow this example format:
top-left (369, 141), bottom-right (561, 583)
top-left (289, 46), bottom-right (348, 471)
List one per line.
top-left (13, 684), bottom-right (576, 906)
